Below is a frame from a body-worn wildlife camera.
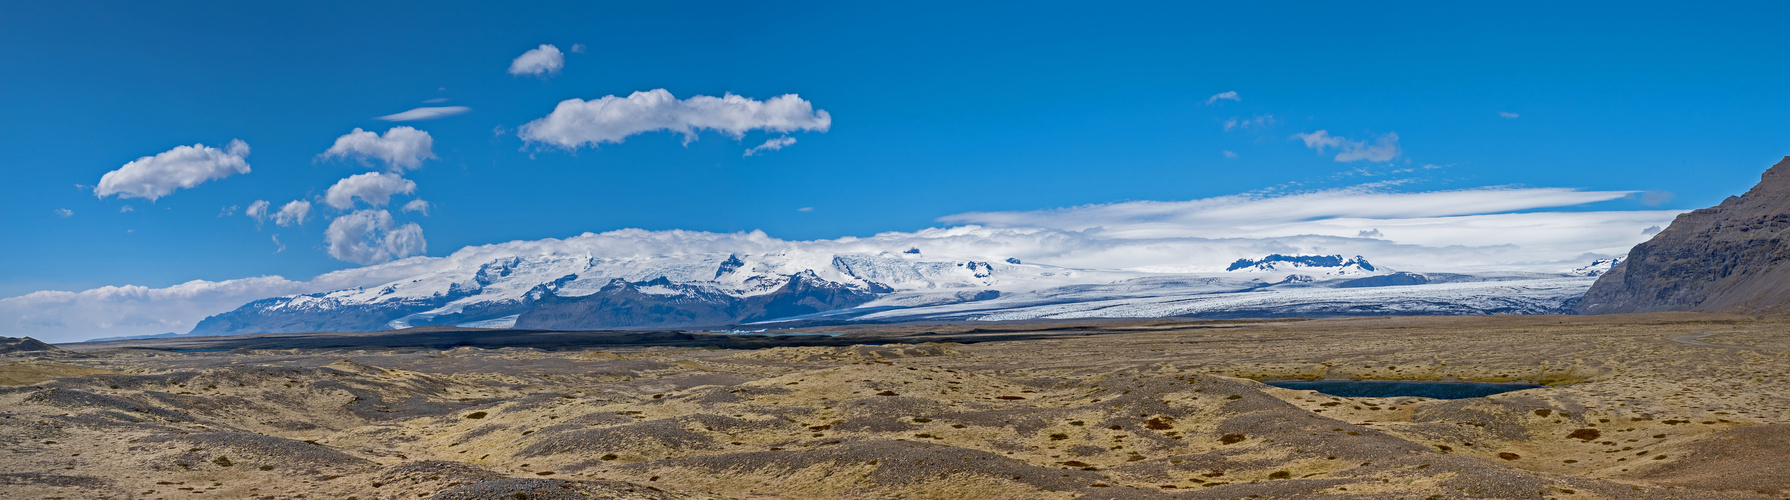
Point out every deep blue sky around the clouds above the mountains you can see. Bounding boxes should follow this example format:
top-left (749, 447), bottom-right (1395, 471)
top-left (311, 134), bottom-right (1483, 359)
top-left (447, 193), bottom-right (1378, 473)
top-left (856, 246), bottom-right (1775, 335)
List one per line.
top-left (0, 2), bottom-right (1790, 297)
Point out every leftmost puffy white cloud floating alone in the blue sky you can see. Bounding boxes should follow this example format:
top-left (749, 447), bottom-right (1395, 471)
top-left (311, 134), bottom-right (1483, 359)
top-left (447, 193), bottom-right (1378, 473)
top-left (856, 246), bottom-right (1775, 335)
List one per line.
top-left (93, 140), bottom-right (249, 201)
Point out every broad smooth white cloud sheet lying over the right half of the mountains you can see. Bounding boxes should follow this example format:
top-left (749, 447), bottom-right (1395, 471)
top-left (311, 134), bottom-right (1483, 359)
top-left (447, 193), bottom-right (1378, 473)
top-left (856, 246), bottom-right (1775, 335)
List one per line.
top-left (940, 188), bottom-right (1679, 272)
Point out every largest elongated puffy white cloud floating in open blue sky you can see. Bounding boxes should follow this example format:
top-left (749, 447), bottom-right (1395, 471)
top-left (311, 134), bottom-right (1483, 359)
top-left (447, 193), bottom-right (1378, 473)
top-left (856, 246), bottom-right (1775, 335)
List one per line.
top-left (517, 88), bottom-right (832, 149)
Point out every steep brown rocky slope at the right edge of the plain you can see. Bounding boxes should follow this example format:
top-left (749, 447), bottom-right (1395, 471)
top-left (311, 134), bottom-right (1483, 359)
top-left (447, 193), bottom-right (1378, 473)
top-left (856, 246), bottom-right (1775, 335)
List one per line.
top-left (1579, 158), bottom-right (1790, 314)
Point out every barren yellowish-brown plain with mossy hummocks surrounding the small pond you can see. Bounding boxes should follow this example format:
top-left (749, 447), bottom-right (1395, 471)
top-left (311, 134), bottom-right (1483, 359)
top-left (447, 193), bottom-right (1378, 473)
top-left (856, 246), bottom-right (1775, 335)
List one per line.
top-left (0, 314), bottom-right (1790, 500)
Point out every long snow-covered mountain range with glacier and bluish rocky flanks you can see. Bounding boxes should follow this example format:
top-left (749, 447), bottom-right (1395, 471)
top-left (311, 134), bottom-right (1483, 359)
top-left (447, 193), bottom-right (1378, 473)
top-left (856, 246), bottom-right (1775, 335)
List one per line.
top-left (192, 238), bottom-right (1607, 335)
